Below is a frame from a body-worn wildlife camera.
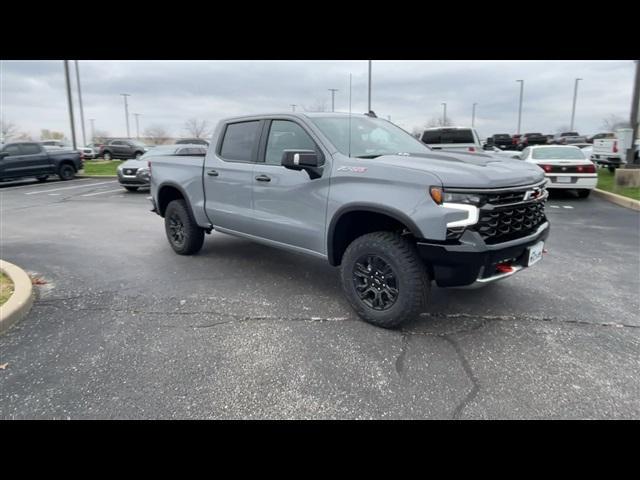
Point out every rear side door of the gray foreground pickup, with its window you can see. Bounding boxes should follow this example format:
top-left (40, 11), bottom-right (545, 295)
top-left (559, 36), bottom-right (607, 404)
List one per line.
top-left (202, 120), bottom-right (263, 234)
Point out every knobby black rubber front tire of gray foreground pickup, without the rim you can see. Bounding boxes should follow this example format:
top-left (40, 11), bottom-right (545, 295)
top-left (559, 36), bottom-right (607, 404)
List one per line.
top-left (340, 232), bottom-right (431, 328)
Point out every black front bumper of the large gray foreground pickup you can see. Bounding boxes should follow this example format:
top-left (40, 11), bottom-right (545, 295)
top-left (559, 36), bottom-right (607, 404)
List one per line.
top-left (417, 222), bottom-right (550, 287)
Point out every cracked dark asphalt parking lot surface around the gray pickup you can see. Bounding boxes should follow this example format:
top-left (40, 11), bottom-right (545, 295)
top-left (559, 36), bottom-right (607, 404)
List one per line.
top-left (0, 179), bottom-right (640, 419)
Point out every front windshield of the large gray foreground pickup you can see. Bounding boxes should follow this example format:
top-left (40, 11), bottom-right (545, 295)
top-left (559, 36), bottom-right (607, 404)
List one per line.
top-left (311, 116), bottom-right (431, 158)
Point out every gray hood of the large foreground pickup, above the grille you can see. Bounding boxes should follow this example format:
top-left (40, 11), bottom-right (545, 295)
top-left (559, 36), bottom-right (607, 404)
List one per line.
top-left (370, 152), bottom-right (544, 188)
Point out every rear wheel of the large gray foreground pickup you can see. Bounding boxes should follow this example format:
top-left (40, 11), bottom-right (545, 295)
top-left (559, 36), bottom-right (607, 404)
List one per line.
top-left (164, 200), bottom-right (204, 255)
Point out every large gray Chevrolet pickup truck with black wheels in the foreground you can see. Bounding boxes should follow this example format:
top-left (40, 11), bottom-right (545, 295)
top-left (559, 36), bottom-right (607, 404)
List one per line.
top-left (150, 113), bottom-right (549, 328)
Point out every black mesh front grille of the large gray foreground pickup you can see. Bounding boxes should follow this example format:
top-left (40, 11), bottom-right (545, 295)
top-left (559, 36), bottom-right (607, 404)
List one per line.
top-left (471, 201), bottom-right (547, 244)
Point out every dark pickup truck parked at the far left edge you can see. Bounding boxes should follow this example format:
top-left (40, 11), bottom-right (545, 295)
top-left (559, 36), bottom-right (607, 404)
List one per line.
top-left (0, 142), bottom-right (83, 182)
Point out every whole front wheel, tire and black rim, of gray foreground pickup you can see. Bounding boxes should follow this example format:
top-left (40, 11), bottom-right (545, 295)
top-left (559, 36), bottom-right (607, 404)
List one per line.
top-left (340, 232), bottom-right (430, 328)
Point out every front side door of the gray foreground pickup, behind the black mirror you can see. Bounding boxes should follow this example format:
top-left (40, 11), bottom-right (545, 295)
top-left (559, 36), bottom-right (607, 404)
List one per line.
top-left (253, 119), bottom-right (330, 254)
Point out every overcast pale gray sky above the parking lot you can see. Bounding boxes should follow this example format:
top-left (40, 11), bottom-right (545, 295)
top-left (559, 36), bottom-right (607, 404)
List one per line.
top-left (0, 60), bottom-right (634, 141)
